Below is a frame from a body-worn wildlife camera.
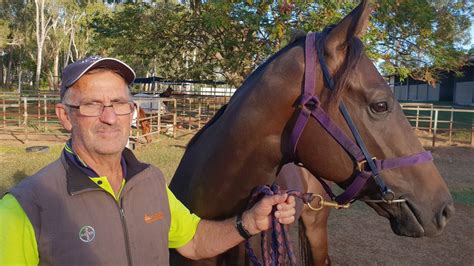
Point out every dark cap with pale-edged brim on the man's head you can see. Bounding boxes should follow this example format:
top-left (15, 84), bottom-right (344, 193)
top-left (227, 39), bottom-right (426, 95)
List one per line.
top-left (61, 56), bottom-right (135, 99)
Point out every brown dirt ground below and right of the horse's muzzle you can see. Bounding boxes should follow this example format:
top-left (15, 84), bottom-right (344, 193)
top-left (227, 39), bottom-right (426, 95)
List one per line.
top-left (329, 141), bottom-right (474, 266)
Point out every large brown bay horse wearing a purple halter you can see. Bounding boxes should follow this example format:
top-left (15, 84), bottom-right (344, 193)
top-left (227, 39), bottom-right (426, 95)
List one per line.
top-left (170, 1), bottom-right (454, 265)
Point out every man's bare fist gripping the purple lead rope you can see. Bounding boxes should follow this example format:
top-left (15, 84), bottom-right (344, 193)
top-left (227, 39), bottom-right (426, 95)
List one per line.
top-left (242, 193), bottom-right (296, 235)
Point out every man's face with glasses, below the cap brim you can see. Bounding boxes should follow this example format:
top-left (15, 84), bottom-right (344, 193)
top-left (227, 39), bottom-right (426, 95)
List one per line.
top-left (57, 71), bottom-right (132, 158)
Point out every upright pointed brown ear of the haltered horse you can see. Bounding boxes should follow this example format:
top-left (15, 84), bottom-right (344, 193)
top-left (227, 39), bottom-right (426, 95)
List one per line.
top-left (325, 0), bottom-right (370, 56)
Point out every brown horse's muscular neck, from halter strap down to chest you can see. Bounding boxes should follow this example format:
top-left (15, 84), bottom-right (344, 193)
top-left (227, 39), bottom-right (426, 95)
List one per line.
top-left (172, 45), bottom-right (304, 218)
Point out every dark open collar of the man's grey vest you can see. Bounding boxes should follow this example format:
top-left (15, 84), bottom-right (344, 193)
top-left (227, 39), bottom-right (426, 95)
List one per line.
top-left (61, 148), bottom-right (149, 195)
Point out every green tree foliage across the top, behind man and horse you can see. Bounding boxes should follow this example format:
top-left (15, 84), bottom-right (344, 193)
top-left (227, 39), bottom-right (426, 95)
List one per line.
top-left (0, 0), bottom-right (473, 87)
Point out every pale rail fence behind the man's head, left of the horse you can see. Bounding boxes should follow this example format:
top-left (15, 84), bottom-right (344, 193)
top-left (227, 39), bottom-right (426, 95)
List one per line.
top-left (0, 93), bottom-right (230, 143)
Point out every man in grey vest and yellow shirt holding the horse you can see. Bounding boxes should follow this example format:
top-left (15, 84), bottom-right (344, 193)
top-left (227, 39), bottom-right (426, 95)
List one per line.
top-left (0, 57), bottom-right (295, 265)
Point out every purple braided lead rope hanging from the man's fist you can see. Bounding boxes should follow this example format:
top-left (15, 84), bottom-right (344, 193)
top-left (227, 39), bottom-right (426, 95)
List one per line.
top-left (245, 184), bottom-right (314, 266)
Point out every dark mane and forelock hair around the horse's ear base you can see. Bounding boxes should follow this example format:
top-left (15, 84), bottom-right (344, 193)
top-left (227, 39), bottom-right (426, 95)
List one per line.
top-left (318, 26), bottom-right (364, 109)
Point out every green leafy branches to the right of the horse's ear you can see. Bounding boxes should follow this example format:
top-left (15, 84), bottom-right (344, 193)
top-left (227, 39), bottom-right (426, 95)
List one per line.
top-left (372, 0), bottom-right (473, 84)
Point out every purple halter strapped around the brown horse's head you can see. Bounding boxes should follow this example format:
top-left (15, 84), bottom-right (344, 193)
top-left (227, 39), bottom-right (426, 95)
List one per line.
top-left (290, 33), bottom-right (433, 204)
